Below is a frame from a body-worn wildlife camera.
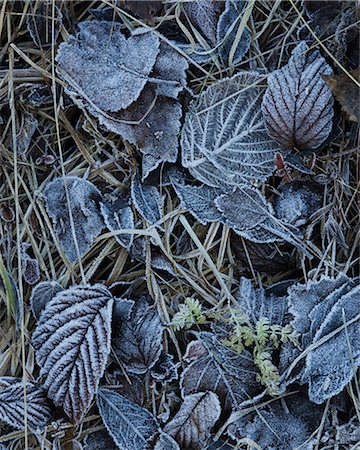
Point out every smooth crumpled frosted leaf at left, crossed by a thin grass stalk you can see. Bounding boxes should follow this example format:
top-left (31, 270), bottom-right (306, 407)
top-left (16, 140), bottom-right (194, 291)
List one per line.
top-left (43, 176), bottom-right (104, 263)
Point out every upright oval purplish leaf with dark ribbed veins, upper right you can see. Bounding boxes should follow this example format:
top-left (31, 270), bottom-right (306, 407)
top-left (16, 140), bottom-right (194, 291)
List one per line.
top-left (262, 41), bottom-right (334, 150)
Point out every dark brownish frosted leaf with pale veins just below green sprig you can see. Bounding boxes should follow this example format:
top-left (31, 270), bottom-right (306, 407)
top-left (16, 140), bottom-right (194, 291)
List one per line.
top-left (181, 332), bottom-right (258, 409)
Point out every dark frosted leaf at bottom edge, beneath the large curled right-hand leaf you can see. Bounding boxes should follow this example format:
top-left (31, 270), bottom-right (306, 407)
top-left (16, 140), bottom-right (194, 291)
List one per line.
top-left (229, 394), bottom-right (323, 450)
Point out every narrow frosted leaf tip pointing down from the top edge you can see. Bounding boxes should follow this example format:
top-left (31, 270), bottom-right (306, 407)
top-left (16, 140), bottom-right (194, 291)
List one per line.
top-left (182, 0), bottom-right (221, 46)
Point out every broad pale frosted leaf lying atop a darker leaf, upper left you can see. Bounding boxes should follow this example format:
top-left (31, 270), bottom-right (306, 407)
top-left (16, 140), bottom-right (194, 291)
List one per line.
top-left (56, 20), bottom-right (160, 112)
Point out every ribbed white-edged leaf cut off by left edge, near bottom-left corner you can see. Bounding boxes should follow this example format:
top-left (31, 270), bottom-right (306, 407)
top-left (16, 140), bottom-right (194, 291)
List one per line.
top-left (0, 377), bottom-right (53, 431)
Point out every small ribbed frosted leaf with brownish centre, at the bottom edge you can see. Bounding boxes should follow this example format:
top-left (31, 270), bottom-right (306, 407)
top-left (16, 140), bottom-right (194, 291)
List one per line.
top-left (164, 392), bottom-right (221, 450)
